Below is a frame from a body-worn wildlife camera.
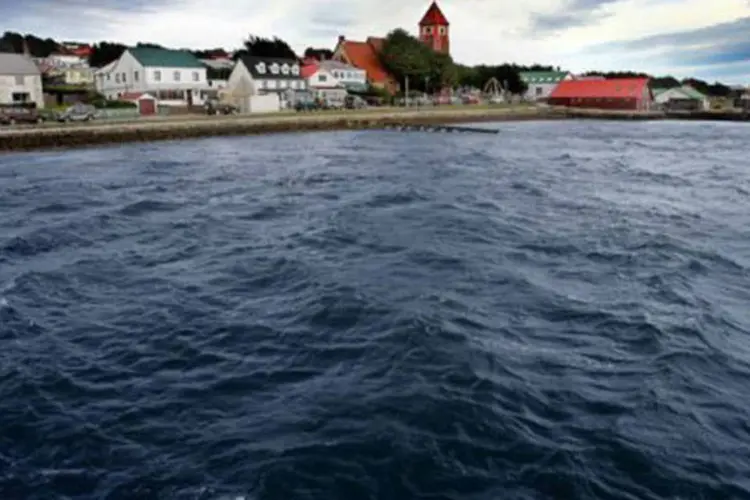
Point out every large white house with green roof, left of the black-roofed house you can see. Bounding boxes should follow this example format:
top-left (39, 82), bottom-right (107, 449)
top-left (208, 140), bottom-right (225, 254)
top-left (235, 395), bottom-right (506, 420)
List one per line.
top-left (96, 47), bottom-right (209, 106)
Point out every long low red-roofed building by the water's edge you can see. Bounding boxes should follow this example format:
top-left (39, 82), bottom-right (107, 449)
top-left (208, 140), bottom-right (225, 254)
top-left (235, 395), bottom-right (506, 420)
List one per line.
top-left (547, 78), bottom-right (654, 111)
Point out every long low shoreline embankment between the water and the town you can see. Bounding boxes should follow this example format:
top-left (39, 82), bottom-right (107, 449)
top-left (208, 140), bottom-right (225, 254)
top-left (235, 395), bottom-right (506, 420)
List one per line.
top-left (0, 106), bottom-right (748, 153)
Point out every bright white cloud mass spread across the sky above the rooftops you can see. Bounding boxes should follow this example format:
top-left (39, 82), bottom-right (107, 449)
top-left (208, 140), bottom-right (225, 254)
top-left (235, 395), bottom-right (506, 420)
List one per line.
top-left (8, 0), bottom-right (750, 79)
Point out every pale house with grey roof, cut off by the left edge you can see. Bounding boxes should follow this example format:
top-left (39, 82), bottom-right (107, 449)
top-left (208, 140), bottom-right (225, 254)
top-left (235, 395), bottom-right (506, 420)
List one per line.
top-left (0, 53), bottom-right (44, 108)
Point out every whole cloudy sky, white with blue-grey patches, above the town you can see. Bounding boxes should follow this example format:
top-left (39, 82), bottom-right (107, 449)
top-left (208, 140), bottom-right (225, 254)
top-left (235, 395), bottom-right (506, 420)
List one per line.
top-left (0, 0), bottom-right (750, 84)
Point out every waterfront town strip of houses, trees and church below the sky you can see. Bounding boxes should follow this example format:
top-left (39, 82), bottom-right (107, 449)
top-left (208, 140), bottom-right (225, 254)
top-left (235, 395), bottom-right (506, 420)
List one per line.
top-left (0, 2), bottom-right (750, 124)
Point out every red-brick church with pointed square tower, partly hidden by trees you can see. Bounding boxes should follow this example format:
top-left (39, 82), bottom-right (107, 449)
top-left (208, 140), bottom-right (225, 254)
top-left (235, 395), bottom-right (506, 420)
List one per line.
top-left (333, 1), bottom-right (450, 93)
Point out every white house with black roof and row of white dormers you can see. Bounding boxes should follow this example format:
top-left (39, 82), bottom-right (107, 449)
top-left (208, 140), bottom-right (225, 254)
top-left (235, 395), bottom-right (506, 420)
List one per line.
top-left (225, 55), bottom-right (308, 113)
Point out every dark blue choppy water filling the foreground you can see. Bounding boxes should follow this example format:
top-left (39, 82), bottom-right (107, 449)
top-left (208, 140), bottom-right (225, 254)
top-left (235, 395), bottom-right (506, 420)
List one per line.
top-left (0, 122), bottom-right (750, 500)
